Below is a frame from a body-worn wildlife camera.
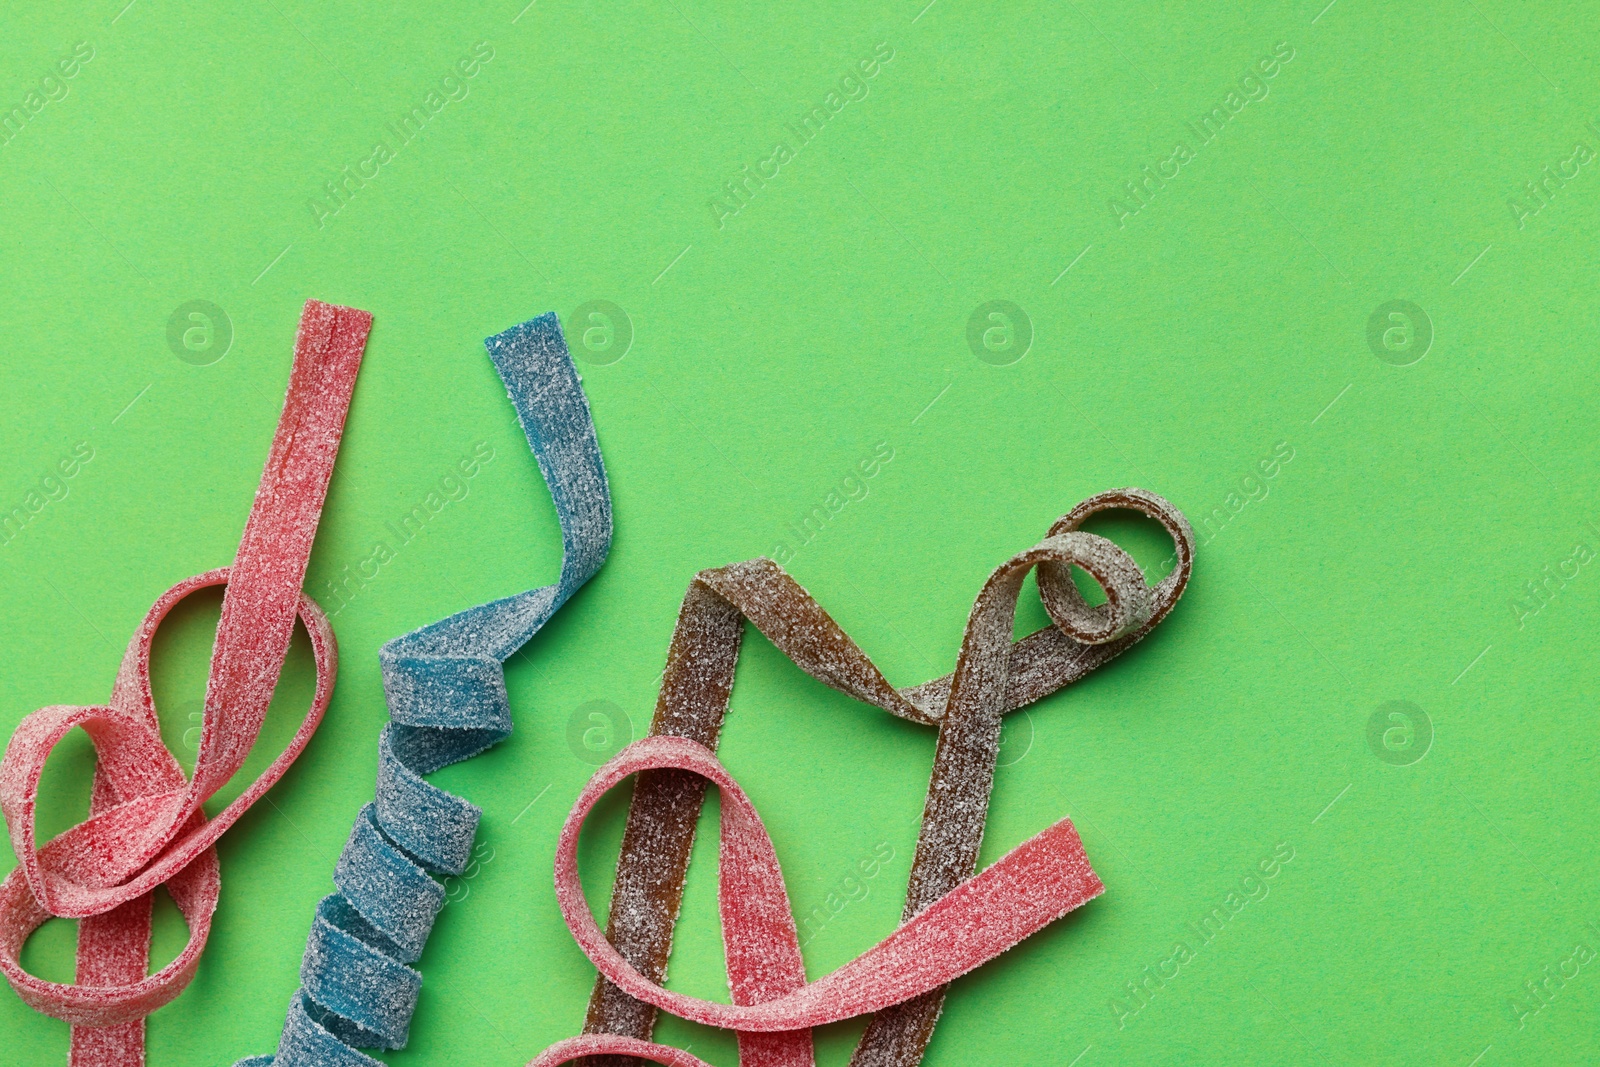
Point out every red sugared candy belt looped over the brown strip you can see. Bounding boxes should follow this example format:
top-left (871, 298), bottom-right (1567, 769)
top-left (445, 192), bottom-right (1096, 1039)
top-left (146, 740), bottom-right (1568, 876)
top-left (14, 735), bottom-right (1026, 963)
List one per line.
top-left (550, 736), bottom-right (1104, 1049)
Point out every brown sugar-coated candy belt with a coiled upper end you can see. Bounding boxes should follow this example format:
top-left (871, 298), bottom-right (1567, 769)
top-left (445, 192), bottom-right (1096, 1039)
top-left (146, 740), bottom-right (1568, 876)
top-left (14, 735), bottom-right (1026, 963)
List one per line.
top-left (572, 490), bottom-right (1194, 1067)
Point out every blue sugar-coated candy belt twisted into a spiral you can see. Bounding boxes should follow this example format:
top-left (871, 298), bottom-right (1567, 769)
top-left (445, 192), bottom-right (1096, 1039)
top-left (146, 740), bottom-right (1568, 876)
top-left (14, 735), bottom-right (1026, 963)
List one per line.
top-left (237, 314), bottom-right (611, 1067)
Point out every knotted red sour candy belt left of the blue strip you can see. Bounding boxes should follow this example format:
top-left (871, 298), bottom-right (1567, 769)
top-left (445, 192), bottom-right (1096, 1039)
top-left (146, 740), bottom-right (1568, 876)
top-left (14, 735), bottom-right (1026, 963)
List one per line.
top-left (0, 301), bottom-right (373, 1067)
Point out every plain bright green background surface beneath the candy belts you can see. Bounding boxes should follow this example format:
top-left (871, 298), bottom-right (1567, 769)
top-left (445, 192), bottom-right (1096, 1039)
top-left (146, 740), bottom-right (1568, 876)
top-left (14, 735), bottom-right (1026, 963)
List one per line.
top-left (0, 0), bottom-right (1600, 1067)
